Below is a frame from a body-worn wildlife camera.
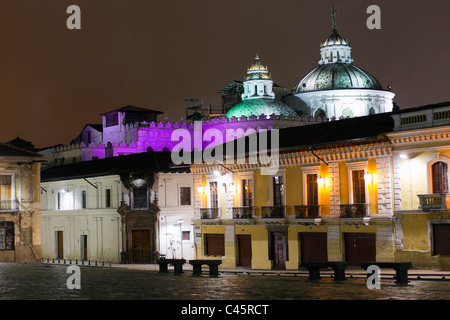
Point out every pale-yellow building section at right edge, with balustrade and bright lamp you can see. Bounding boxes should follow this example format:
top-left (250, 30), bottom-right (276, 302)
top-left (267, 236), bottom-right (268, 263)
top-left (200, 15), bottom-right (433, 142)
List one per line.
top-left (387, 102), bottom-right (450, 269)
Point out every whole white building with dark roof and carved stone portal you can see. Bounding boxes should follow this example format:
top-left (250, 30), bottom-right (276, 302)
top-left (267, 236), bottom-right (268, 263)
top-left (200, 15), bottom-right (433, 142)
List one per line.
top-left (41, 152), bottom-right (193, 263)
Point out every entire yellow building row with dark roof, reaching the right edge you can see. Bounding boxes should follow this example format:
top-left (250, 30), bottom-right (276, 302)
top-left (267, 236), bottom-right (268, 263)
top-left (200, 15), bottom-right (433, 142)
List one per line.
top-left (192, 102), bottom-right (450, 269)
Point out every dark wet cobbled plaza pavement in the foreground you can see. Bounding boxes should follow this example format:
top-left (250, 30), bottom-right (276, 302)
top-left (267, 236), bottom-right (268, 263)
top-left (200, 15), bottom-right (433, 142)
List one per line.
top-left (0, 263), bottom-right (450, 301)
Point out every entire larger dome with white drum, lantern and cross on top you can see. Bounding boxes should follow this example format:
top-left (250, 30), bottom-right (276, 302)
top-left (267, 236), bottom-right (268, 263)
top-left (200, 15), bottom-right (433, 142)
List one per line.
top-left (290, 5), bottom-right (394, 118)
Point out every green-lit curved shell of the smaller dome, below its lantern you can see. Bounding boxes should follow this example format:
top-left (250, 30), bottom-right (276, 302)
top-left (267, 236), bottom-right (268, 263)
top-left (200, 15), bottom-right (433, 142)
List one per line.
top-left (225, 98), bottom-right (297, 118)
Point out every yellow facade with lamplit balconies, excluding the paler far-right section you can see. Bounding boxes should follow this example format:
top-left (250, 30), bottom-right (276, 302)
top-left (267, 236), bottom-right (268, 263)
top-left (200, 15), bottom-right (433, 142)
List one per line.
top-left (191, 114), bottom-right (395, 270)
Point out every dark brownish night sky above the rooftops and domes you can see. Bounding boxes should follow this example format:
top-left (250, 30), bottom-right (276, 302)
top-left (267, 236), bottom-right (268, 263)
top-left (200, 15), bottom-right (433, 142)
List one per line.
top-left (0, 0), bottom-right (450, 147)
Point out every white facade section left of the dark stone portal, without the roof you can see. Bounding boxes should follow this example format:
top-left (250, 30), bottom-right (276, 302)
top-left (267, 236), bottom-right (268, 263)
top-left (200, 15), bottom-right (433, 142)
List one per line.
top-left (41, 175), bottom-right (126, 263)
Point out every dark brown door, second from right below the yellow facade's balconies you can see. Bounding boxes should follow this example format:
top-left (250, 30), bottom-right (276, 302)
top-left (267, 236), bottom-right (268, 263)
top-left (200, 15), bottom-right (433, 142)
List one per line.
top-left (300, 232), bottom-right (328, 263)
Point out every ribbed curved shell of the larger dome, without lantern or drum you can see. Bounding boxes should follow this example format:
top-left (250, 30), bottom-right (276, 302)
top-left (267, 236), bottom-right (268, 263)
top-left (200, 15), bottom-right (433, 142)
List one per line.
top-left (294, 63), bottom-right (382, 93)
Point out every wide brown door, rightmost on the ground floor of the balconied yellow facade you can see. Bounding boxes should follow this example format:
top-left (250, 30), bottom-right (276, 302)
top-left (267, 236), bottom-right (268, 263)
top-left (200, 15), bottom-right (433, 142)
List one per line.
top-left (344, 233), bottom-right (376, 267)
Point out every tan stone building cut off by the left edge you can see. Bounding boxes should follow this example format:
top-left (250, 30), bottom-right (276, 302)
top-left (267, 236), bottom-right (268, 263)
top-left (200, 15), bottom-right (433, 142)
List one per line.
top-left (0, 139), bottom-right (46, 263)
